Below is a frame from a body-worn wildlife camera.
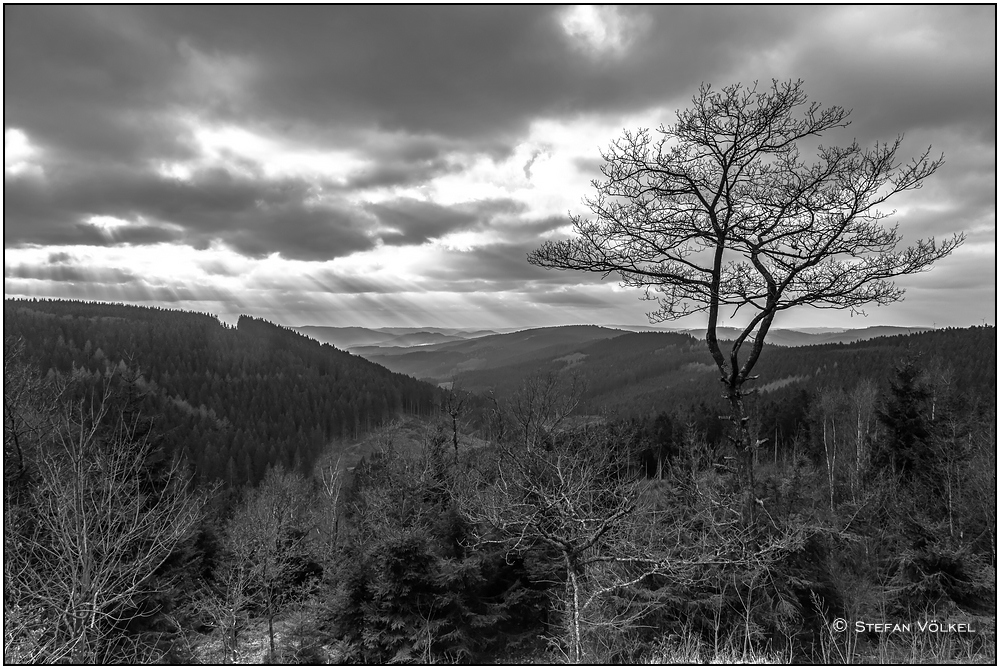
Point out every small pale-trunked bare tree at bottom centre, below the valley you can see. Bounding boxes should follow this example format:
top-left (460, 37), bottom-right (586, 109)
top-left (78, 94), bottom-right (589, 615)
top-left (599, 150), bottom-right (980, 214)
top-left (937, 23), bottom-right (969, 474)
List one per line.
top-left (455, 418), bottom-right (658, 662)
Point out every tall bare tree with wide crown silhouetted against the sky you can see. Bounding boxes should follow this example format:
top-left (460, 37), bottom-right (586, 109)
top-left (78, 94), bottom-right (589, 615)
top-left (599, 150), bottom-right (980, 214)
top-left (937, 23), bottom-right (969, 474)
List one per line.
top-left (528, 81), bottom-right (964, 508)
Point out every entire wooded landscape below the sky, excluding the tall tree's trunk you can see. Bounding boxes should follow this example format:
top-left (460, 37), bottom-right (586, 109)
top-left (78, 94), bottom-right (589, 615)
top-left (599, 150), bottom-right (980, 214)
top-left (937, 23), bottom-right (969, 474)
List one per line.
top-left (4, 300), bottom-right (997, 663)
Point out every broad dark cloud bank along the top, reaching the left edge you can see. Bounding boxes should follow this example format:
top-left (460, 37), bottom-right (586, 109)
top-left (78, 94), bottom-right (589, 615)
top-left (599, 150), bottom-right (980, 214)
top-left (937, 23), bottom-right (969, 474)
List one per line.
top-left (4, 6), bottom-right (820, 159)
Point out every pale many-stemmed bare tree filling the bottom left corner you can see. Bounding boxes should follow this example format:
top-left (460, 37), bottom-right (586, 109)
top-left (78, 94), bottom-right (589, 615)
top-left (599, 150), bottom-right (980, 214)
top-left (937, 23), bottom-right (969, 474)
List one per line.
top-left (4, 380), bottom-right (204, 663)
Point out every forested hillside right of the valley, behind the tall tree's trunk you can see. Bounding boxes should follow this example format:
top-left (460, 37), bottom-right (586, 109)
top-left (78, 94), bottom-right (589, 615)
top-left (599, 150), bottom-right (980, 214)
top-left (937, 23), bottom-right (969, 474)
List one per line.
top-left (458, 327), bottom-right (997, 415)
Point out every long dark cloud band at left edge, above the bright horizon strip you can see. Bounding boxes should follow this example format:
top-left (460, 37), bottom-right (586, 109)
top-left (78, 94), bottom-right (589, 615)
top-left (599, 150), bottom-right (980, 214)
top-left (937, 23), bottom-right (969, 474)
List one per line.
top-left (4, 166), bottom-right (375, 260)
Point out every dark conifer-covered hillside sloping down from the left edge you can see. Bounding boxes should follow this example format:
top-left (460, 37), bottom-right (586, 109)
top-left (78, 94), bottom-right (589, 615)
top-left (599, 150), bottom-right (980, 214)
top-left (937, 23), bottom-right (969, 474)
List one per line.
top-left (4, 300), bottom-right (435, 484)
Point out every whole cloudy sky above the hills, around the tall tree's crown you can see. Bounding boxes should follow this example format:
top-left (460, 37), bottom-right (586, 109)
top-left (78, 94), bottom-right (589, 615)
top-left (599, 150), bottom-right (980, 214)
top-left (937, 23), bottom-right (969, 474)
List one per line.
top-left (4, 6), bottom-right (997, 327)
